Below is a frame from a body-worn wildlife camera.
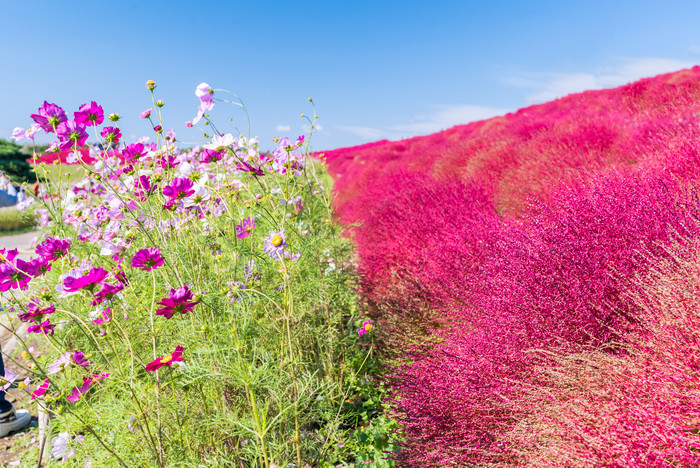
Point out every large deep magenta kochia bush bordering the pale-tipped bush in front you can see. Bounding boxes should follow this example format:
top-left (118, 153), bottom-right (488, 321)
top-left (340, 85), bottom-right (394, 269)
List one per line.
top-left (395, 173), bottom-right (700, 466)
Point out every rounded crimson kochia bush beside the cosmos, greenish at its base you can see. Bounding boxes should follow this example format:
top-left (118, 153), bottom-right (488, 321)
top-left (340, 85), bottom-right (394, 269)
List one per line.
top-left (353, 171), bottom-right (500, 328)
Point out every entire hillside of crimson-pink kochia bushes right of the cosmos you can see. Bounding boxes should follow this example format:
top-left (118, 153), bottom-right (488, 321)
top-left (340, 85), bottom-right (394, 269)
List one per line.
top-left (323, 67), bottom-right (700, 467)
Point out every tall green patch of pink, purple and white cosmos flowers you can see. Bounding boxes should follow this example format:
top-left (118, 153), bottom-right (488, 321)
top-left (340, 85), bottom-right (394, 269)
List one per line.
top-left (5, 81), bottom-right (392, 467)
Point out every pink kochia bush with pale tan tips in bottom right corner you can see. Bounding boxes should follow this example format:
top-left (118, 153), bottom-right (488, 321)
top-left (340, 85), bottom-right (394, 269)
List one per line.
top-left (502, 238), bottom-right (700, 468)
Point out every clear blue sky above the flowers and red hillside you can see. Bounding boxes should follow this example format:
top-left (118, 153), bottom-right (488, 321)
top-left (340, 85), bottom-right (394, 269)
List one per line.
top-left (0, 0), bottom-right (700, 150)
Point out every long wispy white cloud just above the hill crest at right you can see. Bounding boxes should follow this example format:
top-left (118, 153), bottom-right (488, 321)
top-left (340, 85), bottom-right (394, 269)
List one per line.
top-left (505, 57), bottom-right (694, 103)
